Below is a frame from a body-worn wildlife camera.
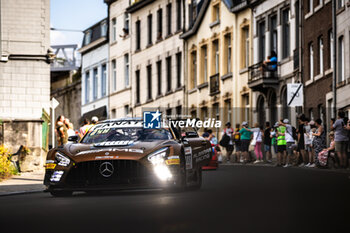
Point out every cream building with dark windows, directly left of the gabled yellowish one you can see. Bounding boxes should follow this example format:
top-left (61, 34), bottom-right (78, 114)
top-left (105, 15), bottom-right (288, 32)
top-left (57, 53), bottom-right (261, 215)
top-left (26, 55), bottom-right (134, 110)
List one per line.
top-left (127, 0), bottom-right (185, 116)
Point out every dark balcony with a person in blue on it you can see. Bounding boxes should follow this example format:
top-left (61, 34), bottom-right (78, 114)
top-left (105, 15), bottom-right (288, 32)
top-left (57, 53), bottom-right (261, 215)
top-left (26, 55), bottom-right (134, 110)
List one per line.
top-left (248, 62), bottom-right (278, 92)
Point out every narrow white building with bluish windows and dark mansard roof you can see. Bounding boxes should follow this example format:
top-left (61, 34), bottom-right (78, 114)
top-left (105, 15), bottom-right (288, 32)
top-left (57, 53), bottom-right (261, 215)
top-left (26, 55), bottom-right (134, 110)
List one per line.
top-left (78, 19), bottom-right (109, 120)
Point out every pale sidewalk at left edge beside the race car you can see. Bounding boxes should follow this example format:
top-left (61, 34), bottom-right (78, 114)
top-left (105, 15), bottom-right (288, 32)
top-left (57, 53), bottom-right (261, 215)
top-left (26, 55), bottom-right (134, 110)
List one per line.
top-left (0, 171), bottom-right (45, 197)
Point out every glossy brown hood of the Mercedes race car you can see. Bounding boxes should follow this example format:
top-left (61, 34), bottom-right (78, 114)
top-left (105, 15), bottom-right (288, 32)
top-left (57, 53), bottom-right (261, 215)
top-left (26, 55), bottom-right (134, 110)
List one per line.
top-left (64, 140), bottom-right (173, 162)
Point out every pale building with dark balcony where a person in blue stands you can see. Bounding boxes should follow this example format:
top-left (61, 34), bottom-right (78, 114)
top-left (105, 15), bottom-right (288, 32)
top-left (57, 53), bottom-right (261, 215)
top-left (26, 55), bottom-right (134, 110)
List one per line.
top-left (248, 0), bottom-right (301, 124)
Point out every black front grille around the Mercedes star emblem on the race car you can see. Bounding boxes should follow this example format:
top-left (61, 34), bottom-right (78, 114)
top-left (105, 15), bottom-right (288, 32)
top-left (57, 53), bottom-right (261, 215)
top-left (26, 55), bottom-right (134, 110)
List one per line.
top-left (66, 160), bottom-right (152, 186)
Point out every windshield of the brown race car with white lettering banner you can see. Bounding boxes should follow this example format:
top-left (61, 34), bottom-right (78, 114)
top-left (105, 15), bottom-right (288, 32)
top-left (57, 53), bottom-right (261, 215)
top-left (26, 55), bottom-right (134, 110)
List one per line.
top-left (81, 127), bottom-right (172, 145)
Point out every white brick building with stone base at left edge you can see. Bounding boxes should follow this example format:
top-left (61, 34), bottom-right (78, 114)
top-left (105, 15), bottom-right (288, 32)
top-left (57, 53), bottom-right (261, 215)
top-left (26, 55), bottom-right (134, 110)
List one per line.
top-left (0, 0), bottom-right (52, 171)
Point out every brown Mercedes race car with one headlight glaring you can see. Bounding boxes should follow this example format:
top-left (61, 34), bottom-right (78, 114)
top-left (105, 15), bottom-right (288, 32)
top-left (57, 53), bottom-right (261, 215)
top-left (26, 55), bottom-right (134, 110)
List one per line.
top-left (44, 118), bottom-right (212, 196)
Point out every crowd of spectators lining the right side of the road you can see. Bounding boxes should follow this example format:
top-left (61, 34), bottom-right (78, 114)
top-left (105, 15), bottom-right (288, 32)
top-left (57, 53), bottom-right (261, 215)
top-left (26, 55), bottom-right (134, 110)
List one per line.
top-left (213, 111), bottom-right (350, 168)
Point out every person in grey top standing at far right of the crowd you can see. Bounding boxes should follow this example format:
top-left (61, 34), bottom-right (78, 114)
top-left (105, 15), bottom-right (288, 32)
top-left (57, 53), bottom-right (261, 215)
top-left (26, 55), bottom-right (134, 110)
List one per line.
top-left (331, 111), bottom-right (349, 168)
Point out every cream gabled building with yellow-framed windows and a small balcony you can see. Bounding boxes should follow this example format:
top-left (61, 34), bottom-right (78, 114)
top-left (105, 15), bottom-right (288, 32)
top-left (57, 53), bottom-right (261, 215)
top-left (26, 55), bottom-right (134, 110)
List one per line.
top-left (181, 0), bottom-right (252, 130)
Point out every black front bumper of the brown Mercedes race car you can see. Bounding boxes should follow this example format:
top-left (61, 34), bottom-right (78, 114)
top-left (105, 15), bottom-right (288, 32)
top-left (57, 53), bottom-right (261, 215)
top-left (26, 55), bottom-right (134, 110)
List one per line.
top-left (44, 160), bottom-right (180, 191)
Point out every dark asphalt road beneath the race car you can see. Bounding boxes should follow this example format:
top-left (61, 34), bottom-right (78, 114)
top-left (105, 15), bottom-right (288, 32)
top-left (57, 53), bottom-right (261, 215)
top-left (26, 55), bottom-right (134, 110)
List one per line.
top-left (0, 166), bottom-right (350, 233)
